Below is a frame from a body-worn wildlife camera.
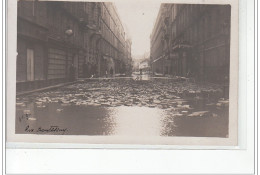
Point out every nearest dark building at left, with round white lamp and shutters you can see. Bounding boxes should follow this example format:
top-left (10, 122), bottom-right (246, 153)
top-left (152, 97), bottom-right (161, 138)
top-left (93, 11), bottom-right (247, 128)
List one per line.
top-left (16, 1), bottom-right (87, 91)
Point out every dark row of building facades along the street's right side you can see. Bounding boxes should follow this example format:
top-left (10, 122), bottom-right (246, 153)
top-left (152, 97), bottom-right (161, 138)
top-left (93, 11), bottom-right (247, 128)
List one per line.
top-left (151, 4), bottom-right (231, 82)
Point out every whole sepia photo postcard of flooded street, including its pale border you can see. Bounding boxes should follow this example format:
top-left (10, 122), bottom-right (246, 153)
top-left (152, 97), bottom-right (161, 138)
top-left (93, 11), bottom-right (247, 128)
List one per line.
top-left (7, 0), bottom-right (238, 146)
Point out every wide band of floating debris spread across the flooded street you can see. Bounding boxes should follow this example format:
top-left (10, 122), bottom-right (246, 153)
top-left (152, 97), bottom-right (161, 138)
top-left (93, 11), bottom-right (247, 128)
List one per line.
top-left (16, 78), bottom-right (226, 116)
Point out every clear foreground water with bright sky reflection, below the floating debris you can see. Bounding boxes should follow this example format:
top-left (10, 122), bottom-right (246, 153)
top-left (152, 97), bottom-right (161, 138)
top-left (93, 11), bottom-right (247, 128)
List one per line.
top-left (16, 103), bottom-right (228, 137)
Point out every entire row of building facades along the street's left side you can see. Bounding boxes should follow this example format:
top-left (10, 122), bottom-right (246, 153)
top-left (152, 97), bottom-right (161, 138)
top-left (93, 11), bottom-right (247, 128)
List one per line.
top-left (16, 0), bottom-right (131, 91)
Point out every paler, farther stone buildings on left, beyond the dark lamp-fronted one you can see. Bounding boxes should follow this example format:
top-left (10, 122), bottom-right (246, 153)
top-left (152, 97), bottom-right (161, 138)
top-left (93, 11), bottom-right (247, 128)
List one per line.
top-left (85, 2), bottom-right (131, 76)
